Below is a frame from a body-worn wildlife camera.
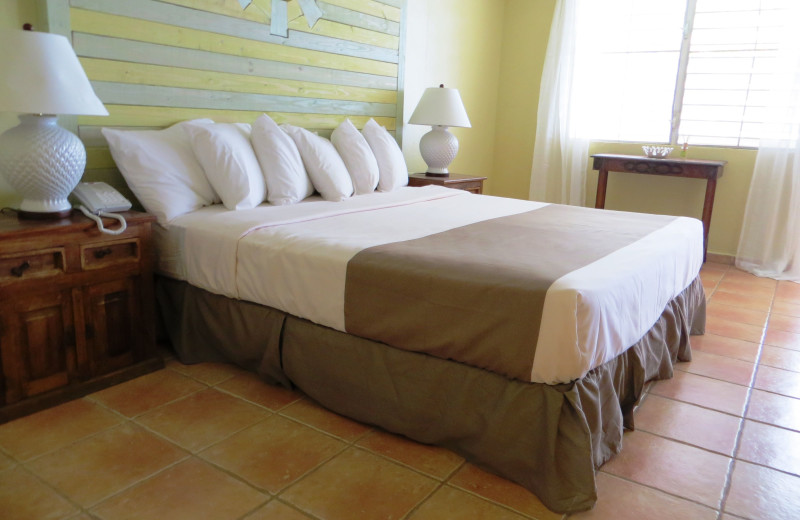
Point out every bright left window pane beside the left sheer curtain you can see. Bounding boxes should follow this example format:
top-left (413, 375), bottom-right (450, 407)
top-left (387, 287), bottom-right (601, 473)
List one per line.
top-left (575, 0), bottom-right (686, 143)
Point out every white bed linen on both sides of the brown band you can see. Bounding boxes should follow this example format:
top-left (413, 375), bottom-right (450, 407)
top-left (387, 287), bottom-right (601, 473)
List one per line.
top-left (170, 186), bottom-right (703, 384)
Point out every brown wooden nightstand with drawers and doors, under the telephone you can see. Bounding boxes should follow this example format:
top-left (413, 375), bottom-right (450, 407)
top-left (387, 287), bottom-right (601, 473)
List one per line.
top-left (0, 211), bottom-right (164, 423)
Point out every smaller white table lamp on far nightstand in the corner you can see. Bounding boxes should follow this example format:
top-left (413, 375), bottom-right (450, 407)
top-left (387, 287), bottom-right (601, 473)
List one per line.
top-left (408, 85), bottom-right (472, 177)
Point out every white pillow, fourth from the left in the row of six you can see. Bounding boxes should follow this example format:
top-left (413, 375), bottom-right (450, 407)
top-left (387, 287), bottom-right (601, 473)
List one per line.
top-left (281, 125), bottom-right (353, 202)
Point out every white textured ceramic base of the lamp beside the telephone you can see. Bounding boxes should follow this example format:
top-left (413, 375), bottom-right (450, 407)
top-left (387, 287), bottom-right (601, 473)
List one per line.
top-left (0, 115), bottom-right (86, 218)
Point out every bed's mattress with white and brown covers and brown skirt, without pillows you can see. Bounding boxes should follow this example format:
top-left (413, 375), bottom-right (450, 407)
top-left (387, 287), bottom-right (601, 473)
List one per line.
top-left (152, 186), bottom-right (705, 512)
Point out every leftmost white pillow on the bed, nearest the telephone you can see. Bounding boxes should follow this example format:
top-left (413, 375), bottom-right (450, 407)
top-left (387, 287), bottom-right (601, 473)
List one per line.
top-left (101, 119), bottom-right (219, 226)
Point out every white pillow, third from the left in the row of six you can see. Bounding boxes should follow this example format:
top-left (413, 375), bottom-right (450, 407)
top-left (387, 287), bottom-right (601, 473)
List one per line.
top-left (250, 114), bottom-right (314, 206)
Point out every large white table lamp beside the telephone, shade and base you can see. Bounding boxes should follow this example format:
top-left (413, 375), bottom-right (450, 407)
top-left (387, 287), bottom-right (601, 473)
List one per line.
top-left (0, 24), bottom-right (108, 219)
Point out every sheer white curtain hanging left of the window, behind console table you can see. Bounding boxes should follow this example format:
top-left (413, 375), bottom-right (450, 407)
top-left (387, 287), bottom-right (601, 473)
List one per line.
top-left (529, 0), bottom-right (589, 206)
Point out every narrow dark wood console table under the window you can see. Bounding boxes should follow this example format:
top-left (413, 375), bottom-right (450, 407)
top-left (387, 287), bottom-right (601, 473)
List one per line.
top-left (592, 153), bottom-right (727, 261)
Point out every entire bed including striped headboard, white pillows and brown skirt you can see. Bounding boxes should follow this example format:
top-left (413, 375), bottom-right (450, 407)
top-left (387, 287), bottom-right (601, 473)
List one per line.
top-left (50, 0), bottom-right (705, 512)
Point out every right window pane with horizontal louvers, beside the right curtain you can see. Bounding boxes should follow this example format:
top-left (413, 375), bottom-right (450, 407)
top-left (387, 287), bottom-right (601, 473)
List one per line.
top-left (676, 0), bottom-right (797, 147)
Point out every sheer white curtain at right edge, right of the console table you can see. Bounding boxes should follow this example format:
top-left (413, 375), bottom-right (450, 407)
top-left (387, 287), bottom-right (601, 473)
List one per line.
top-left (736, 5), bottom-right (800, 281)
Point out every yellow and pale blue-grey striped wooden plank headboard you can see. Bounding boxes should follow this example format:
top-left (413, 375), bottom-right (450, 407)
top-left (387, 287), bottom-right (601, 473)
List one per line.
top-left (40, 0), bottom-right (405, 202)
